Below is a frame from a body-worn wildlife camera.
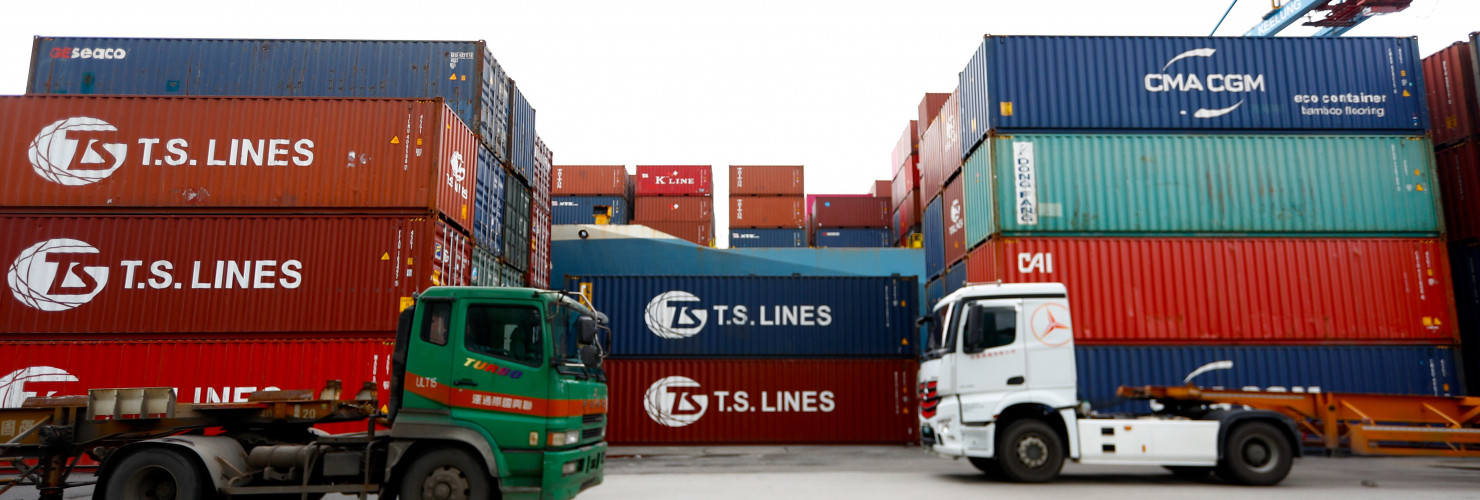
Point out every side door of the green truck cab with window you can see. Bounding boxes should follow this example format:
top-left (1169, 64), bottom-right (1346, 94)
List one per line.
top-left (448, 300), bottom-right (549, 447)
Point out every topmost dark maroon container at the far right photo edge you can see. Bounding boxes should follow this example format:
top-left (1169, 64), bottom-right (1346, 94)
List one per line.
top-left (1424, 41), bottom-right (1480, 145)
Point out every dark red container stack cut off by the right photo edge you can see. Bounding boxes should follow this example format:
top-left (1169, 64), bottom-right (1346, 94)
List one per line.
top-left (1424, 34), bottom-right (1480, 391)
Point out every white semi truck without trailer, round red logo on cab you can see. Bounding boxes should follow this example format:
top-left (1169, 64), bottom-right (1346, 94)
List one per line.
top-left (919, 283), bottom-right (1301, 485)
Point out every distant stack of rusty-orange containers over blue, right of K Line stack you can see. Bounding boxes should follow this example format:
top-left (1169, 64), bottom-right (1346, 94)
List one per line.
top-left (730, 166), bottom-right (807, 249)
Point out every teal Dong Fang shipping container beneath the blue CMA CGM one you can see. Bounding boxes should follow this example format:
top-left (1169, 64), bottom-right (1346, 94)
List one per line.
top-left (965, 135), bottom-right (1440, 244)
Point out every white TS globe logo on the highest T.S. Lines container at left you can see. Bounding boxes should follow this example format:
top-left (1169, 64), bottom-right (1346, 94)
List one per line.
top-left (28, 117), bottom-right (129, 186)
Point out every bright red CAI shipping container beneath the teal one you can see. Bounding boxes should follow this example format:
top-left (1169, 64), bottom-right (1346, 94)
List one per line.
top-left (966, 238), bottom-right (1458, 345)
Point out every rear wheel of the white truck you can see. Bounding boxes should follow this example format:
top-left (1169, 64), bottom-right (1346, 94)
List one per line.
top-left (1218, 422), bottom-right (1294, 487)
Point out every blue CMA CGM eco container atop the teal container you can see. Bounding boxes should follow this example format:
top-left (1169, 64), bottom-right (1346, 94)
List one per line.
top-left (959, 36), bottom-right (1428, 157)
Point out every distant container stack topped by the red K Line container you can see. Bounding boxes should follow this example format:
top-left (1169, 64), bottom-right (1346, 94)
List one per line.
top-left (632, 166), bottom-right (715, 247)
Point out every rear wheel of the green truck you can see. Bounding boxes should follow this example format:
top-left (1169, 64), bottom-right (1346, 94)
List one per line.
top-left (102, 448), bottom-right (210, 500)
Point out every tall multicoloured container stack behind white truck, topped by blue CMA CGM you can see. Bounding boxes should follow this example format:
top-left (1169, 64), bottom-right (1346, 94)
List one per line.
top-left (921, 37), bottom-right (1461, 411)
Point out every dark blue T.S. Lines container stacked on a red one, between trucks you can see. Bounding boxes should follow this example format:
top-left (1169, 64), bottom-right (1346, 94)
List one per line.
top-left (565, 275), bottom-right (919, 358)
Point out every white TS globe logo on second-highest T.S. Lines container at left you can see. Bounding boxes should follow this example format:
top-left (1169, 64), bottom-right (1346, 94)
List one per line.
top-left (6, 238), bottom-right (108, 311)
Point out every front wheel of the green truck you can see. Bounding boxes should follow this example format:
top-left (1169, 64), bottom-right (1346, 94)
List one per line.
top-left (400, 448), bottom-right (493, 500)
